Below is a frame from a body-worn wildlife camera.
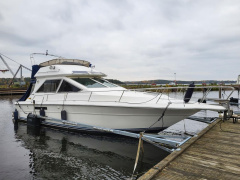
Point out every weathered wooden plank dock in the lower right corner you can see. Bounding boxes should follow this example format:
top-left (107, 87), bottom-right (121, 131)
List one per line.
top-left (139, 119), bottom-right (240, 180)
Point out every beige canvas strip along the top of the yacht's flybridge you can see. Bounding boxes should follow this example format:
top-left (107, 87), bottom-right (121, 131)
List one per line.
top-left (39, 59), bottom-right (91, 67)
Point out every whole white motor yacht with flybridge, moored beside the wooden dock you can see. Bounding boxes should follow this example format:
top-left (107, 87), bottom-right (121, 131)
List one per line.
top-left (16, 59), bottom-right (225, 132)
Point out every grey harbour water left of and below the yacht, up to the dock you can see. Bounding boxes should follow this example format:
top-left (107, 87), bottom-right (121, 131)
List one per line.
top-left (0, 96), bottom-right (168, 180)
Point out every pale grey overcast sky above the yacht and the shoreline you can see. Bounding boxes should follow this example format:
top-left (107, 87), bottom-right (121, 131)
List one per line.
top-left (0, 0), bottom-right (240, 81)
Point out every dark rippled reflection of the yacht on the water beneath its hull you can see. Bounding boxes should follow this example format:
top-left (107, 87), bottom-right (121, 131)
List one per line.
top-left (13, 123), bottom-right (168, 179)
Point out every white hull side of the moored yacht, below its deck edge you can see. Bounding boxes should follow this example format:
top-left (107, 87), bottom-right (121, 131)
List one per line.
top-left (16, 104), bottom-right (199, 132)
